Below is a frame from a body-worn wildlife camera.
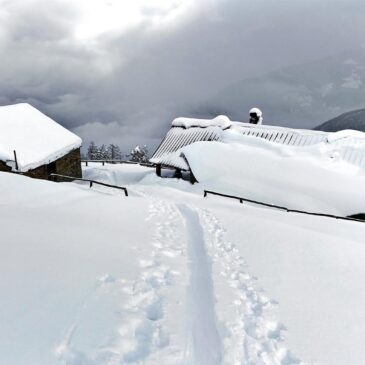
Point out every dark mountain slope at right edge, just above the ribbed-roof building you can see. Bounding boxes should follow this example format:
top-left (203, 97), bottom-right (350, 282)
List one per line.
top-left (314, 109), bottom-right (365, 132)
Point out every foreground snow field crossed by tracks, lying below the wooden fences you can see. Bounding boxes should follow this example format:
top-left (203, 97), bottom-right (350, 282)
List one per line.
top-left (0, 164), bottom-right (365, 365)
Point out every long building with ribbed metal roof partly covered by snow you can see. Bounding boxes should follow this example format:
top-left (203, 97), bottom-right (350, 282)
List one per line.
top-left (150, 116), bottom-right (365, 182)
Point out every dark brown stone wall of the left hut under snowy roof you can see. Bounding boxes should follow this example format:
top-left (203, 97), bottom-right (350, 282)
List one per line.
top-left (0, 148), bottom-right (82, 180)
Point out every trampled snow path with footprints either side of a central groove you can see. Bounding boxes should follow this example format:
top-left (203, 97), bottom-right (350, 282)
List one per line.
top-left (55, 183), bottom-right (303, 365)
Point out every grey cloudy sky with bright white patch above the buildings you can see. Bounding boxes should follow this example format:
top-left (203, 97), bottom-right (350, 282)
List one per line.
top-left (0, 0), bottom-right (365, 151)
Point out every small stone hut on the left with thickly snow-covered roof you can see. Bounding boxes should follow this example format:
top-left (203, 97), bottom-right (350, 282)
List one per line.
top-left (0, 103), bottom-right (82, 179)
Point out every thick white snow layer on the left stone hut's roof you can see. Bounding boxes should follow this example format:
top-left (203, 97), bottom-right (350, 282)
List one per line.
top-left (0, 104), bottom-right (82, 172)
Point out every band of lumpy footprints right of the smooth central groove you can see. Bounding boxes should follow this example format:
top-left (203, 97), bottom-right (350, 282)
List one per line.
top-left (201, 210), bottom-right (303, 365)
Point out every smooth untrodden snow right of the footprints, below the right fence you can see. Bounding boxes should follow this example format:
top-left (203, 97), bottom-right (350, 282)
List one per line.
top-left (209, 199), bottom-right (365, 365)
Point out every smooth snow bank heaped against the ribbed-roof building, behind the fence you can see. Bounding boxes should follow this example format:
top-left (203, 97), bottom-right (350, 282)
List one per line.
top-left (182, 131), bottom-right (365, 215)
